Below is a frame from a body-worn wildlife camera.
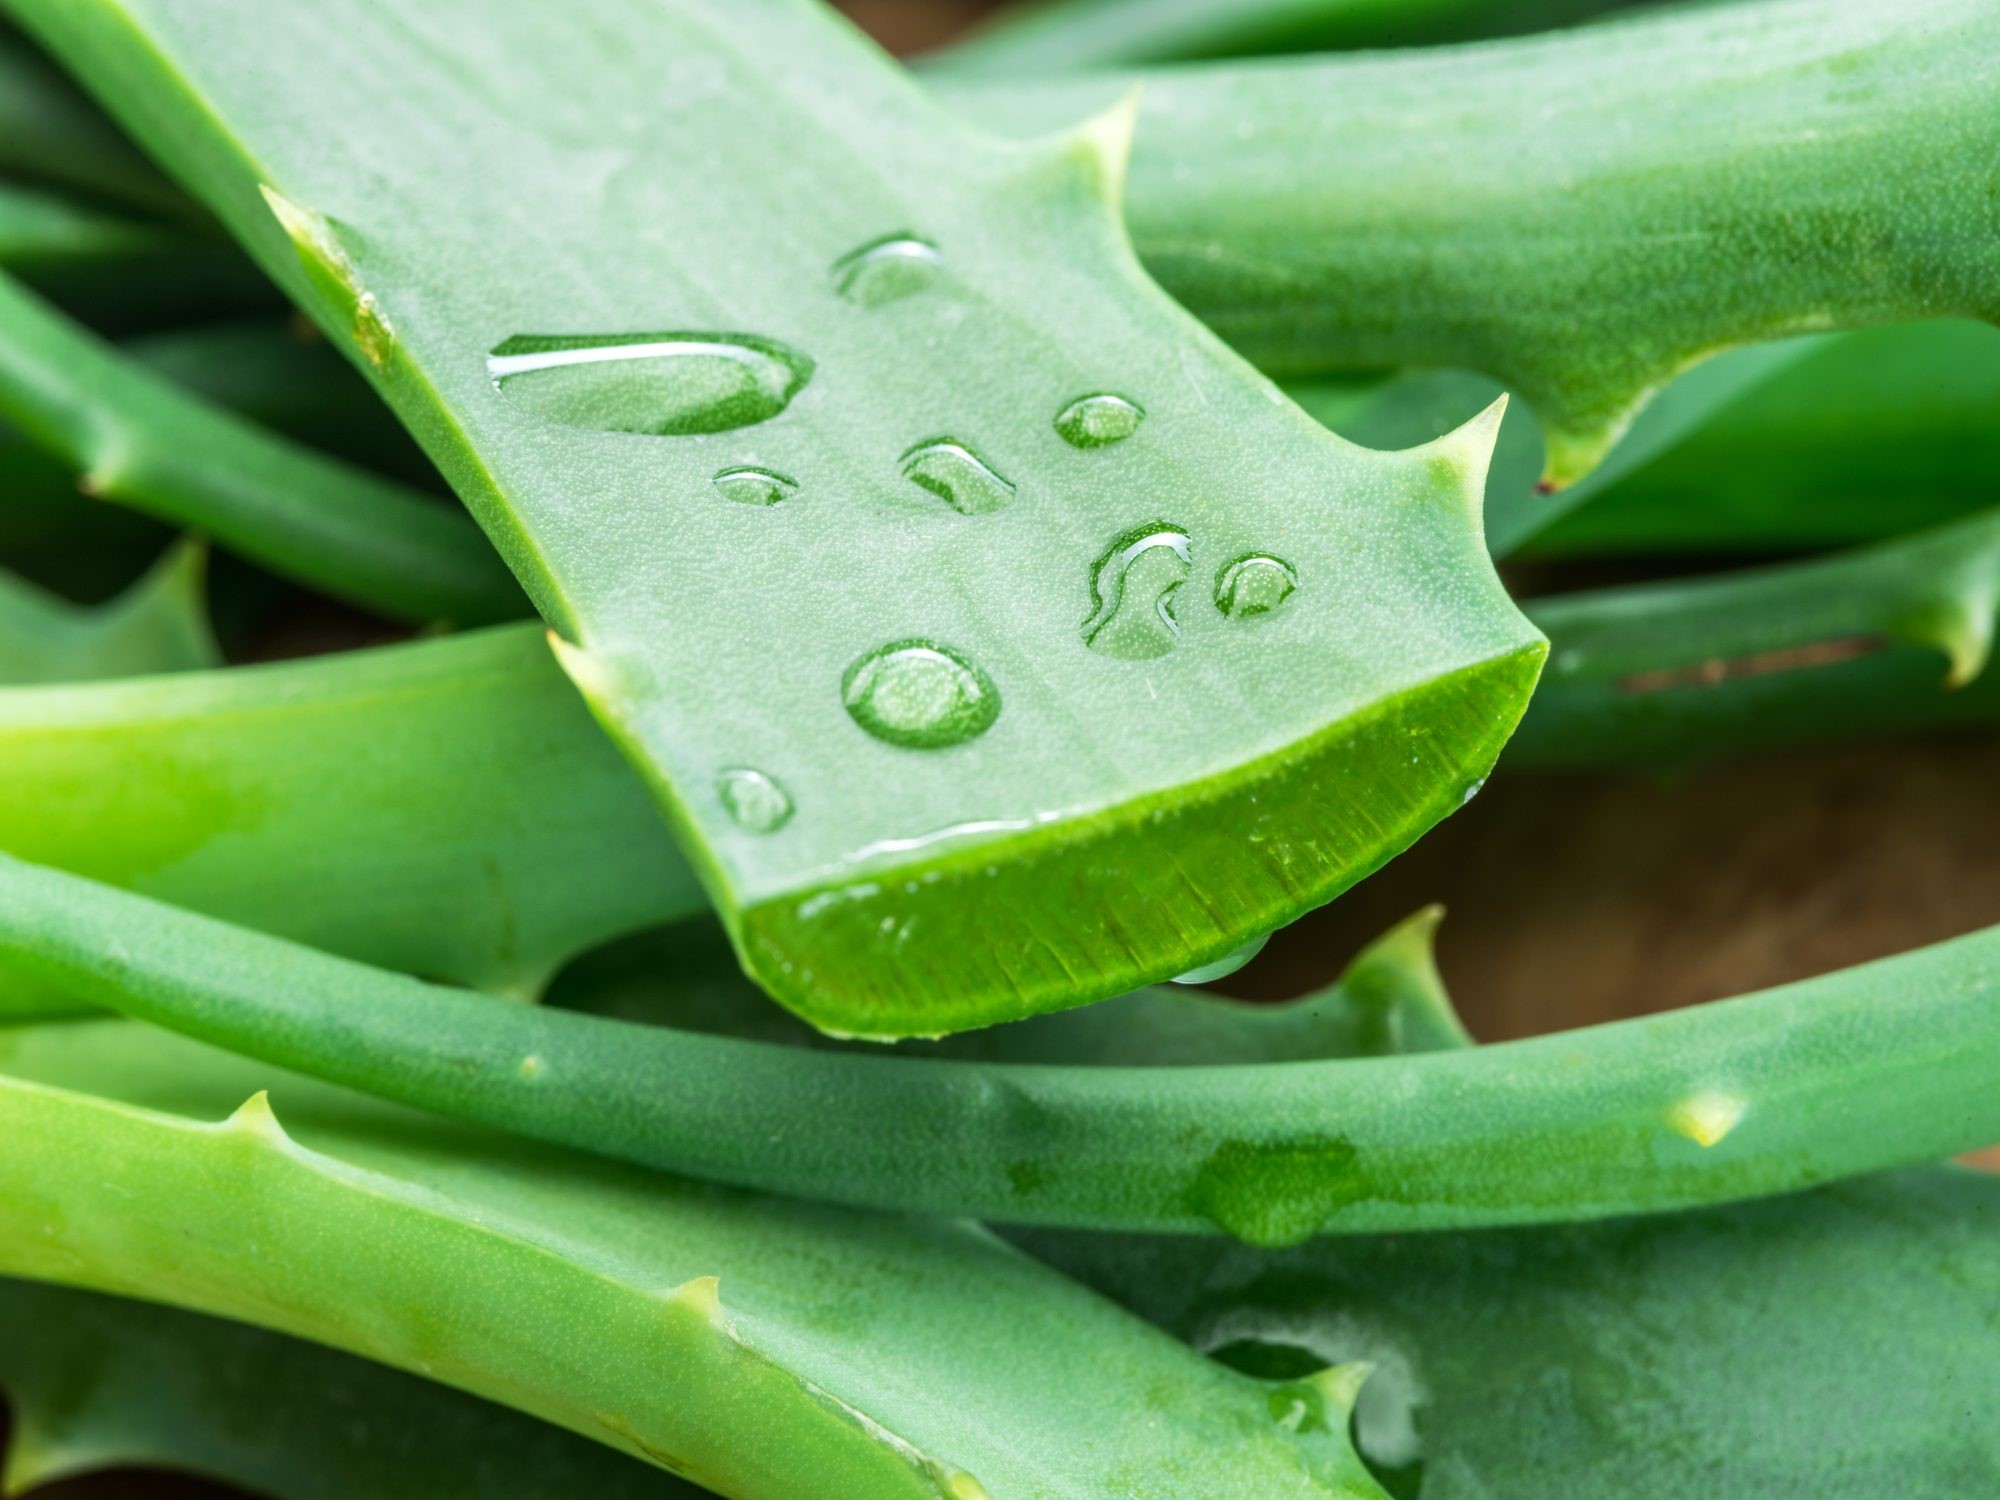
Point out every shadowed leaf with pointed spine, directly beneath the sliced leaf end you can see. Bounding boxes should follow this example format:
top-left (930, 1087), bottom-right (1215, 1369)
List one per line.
top-left (564, 906), bottom-right (1470, 1068)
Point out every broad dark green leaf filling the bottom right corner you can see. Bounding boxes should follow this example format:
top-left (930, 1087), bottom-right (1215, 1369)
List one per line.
top-left (1018, 1168), bottom-right (2000, 1500)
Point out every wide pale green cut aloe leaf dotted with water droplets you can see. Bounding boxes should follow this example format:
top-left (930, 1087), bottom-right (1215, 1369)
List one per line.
top-left (14, 0), bottom-right (1542, 1036)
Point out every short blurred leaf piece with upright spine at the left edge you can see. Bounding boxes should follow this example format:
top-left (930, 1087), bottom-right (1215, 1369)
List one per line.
top-left (0, 542), bottom-right (222, 684)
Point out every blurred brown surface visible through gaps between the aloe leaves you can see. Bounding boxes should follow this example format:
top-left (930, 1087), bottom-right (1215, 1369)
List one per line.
top-left (19, 0), bottom-right (2000, 1500)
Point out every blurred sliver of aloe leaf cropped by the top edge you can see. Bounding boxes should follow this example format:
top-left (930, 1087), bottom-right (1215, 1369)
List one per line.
top-left (924, 0), bottom-right (1616, 78)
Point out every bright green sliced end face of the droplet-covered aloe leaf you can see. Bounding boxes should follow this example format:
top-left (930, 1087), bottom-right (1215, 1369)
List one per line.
top-left (738, 644), bottom-right (1544, 1038)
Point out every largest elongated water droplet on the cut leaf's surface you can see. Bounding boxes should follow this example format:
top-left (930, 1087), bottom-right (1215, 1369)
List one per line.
top-left (486, 334), bottom-right (812, 436)
